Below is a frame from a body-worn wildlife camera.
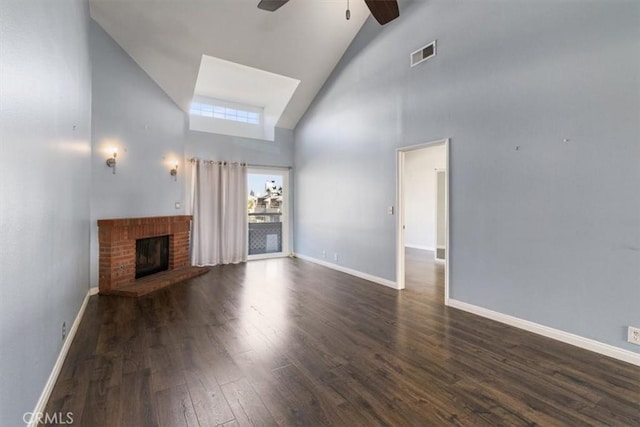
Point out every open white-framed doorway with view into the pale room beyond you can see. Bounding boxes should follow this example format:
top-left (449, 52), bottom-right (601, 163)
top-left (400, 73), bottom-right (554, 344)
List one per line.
top-left (396, 139), bottom-right (449, 304)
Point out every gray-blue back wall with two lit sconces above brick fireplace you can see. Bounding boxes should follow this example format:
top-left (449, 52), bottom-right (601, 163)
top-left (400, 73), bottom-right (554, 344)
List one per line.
top-left (90, 20), bottom-right (293, 287)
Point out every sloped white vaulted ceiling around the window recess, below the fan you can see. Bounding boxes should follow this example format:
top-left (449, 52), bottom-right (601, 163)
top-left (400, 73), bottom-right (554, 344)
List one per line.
top-left (90, 0), bottom-right (369, 129)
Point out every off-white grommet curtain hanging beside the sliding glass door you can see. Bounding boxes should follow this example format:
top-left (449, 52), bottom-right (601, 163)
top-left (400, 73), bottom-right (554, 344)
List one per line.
top-left (191, 160), bottom-right (248, 266)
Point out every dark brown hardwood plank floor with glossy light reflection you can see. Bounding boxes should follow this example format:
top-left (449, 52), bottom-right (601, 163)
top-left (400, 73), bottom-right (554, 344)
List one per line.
top-left (47, 251), bottom-right (640, 427)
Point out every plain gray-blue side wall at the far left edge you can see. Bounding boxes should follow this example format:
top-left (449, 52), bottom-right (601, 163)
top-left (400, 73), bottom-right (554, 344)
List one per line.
top-left (0, 0), bottom-right (91, 426)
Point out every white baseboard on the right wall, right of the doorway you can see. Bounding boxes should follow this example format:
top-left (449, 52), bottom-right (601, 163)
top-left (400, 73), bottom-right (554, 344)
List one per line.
top-left (448, 298), bottom-right (640, 366)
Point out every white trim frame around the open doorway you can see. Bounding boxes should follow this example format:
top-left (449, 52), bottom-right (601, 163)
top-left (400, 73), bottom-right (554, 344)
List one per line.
top-left (396, 138), bottom-right (451, 305)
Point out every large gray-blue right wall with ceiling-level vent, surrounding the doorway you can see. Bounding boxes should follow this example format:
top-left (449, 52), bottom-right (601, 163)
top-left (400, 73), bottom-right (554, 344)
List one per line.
top-left (295, 0), bottom-right (640, 352)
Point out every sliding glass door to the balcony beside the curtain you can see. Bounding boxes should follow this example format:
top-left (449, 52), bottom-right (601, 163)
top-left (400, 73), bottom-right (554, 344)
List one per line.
top-left (247, 168), bottom-right (290, 260)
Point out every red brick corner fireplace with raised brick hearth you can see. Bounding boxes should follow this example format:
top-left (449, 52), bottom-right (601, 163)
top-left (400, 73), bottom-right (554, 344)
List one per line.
top-left (98, 215), bottom-right (208, 296)
